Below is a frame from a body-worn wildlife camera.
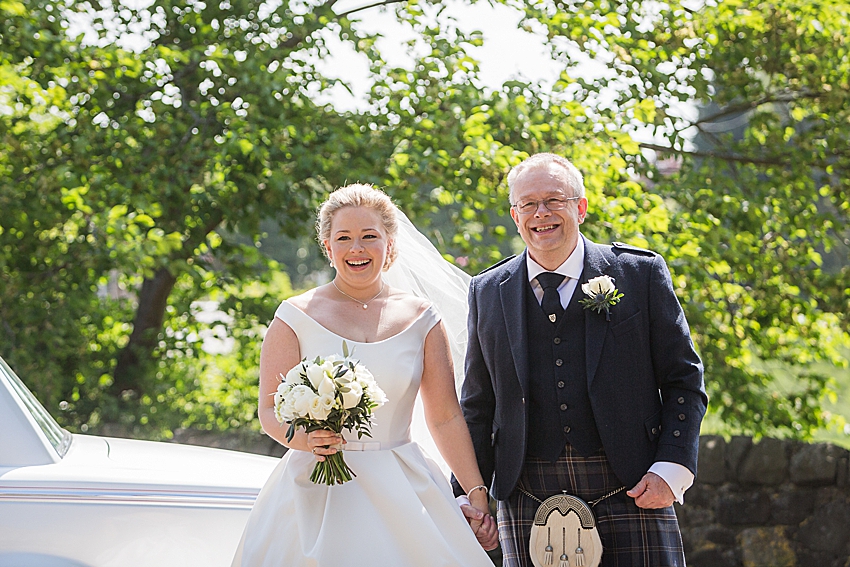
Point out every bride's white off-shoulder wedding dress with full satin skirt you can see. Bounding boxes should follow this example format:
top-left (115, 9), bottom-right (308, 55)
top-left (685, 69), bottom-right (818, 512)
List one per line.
top-left (233, 301), bottom-right (493, 567)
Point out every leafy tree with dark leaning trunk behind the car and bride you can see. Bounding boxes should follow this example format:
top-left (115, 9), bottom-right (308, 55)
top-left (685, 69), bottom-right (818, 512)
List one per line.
top-left (0, 0), bottom-right (636, 434)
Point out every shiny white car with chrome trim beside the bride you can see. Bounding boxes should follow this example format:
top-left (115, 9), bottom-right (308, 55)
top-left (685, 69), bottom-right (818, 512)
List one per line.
top-left (0, 358), bottom-right (278, 567)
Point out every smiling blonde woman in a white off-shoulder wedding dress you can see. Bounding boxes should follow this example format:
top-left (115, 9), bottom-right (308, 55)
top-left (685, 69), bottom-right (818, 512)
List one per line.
top-left (233, 184), bottom-right (497, 567)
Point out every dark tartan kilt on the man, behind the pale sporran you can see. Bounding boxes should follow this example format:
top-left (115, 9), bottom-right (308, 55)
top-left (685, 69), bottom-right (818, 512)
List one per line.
top-left (497, 445), bottom-right (685, 567)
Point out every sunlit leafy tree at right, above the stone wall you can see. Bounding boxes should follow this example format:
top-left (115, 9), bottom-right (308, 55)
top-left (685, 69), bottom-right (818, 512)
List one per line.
top-left (525, 0), bottom-right (850, 435)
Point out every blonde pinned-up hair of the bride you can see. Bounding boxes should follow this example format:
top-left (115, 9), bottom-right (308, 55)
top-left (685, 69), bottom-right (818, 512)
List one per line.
top-left (316, 183), bottom-right (398, 271)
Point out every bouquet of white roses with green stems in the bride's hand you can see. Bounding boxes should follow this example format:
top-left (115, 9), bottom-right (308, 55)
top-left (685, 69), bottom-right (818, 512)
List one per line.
top-left (274, 341), bottom-right (387, 485)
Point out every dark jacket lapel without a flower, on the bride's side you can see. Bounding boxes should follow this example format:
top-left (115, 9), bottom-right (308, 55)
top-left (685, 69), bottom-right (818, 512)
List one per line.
top-left (499, 250), bottom-right (529, 396)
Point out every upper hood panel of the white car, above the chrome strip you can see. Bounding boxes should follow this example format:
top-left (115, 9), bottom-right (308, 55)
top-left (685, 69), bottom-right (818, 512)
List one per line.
top-left (0, 435), bottom-right (280, 495)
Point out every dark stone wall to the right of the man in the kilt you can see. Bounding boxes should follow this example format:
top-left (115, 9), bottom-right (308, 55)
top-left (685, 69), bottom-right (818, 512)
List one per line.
top-left (676, 435), bottom-right (850, 567)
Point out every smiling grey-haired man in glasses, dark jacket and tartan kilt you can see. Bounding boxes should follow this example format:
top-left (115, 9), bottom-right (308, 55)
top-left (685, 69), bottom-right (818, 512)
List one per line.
top-left (455, 154), bottom-right (707, 567)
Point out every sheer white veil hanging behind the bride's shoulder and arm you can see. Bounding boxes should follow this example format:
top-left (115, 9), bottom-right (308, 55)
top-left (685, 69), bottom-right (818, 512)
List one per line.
top-left (383, 209), bottom-right (471, 476)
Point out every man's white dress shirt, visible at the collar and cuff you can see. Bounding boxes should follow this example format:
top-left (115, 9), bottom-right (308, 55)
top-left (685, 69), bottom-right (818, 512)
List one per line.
top-left (525, 236), bottom-right (694, 504)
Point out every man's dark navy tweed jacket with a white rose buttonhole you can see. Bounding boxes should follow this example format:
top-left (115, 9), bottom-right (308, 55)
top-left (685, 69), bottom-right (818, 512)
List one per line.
top-left (454, 236), bottom-right (708, 500)
